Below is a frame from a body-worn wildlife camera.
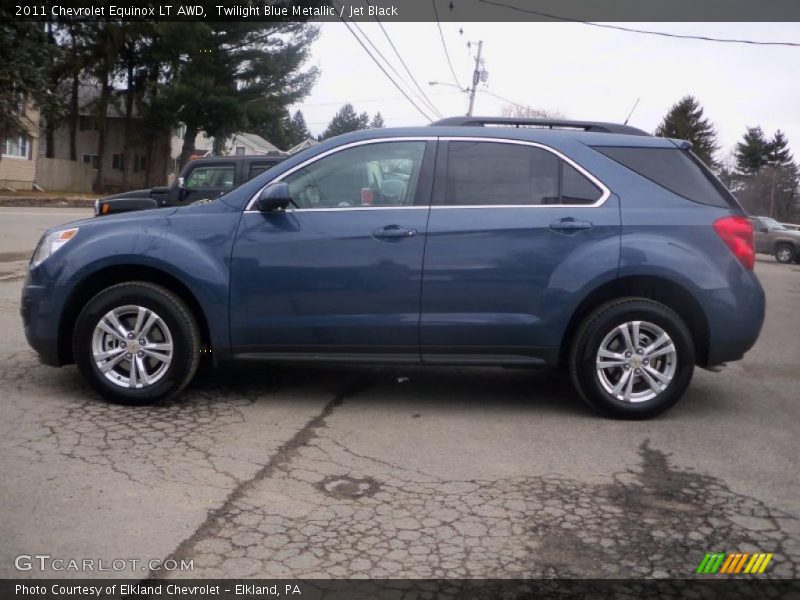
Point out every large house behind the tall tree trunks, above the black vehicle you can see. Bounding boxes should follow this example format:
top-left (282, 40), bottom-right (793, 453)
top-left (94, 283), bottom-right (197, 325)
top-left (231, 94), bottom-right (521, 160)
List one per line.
top-left (37, 84), bottom-right (169, 192)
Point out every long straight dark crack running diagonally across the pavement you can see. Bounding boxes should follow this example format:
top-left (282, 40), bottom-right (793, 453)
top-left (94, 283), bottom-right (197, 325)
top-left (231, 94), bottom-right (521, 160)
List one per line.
top-left (153, 376), bottom-right (372, 579)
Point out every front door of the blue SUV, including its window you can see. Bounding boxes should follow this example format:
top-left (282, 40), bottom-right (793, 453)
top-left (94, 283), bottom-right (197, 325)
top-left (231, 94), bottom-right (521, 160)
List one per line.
top-left (230, 138), bottom-right (435, 361)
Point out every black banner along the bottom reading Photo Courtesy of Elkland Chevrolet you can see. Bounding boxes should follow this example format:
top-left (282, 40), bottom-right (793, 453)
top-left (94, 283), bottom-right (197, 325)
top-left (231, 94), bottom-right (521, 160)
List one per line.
top-left (0, 576), bottom-right (800, 600)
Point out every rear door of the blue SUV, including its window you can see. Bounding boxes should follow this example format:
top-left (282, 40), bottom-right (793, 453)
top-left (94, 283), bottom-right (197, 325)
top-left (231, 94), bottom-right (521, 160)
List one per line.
top-left (420, 138), bottom-right (620, 364)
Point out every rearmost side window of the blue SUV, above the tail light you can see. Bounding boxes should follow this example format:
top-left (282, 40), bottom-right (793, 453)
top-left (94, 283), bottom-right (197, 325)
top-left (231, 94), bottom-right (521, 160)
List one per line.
top-left (595, 146), bottom-right (730, 207)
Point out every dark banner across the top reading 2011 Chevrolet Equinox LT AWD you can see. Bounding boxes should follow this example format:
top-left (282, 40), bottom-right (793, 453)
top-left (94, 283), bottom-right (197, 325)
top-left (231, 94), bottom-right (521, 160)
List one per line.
top-left (2, 0), bottom-right (800, 22)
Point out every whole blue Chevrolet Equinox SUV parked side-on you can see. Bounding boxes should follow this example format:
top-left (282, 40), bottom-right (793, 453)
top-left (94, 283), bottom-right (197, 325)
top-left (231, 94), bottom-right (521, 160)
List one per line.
top-left (22, 117), bottom-right (765, 418)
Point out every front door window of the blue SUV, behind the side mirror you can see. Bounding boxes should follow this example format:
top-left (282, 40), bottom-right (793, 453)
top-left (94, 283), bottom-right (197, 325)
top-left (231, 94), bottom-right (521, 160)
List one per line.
top-left (283, 142), bottom-right (425, 208)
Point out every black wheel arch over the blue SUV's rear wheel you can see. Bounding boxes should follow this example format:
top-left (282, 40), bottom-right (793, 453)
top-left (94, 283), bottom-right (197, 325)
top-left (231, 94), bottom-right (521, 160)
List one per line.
top-left (558, 275), bottom-right (709, 366)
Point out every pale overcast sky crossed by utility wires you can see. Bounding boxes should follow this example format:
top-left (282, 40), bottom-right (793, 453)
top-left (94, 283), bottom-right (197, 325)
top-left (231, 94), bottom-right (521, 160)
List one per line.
top-left (292, 22), bottom-right (800, 158)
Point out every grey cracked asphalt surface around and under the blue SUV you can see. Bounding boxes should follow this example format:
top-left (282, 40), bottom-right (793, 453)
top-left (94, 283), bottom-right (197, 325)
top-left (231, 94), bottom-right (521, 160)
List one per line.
top-left (0, 209), bottom-right (800, 578)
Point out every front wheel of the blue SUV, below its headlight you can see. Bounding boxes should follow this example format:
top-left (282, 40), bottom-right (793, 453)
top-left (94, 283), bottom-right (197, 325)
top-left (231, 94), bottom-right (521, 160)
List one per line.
top-left (73, 281), bottom-right (200, 404)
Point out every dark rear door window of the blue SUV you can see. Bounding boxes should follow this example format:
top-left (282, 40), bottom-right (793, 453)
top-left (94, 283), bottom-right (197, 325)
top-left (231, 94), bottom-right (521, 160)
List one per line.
top-left (445, 142), bottom-right (602, 206)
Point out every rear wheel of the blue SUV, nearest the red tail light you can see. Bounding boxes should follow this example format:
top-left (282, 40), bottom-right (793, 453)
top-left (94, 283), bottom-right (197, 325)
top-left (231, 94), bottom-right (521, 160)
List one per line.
top-left (570, 298), bottom-right (695, 419)
